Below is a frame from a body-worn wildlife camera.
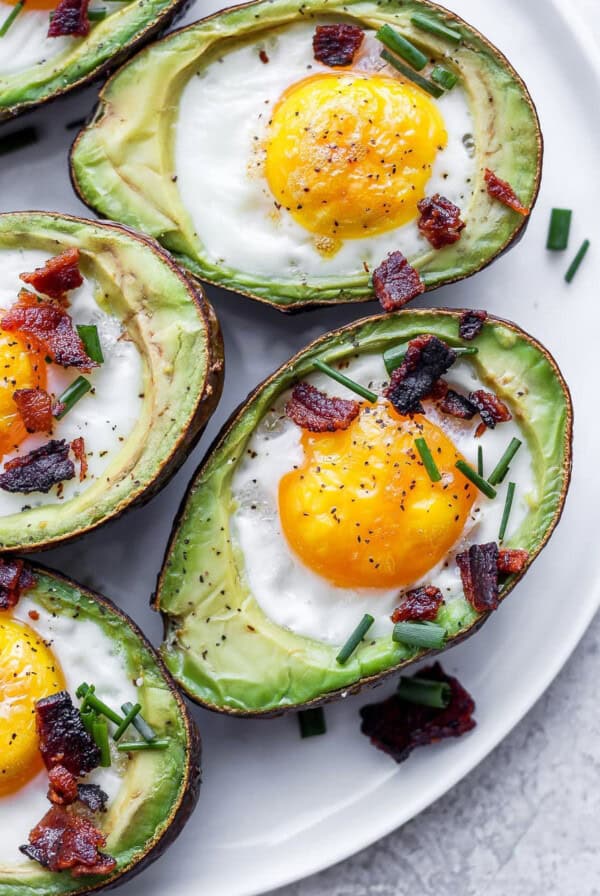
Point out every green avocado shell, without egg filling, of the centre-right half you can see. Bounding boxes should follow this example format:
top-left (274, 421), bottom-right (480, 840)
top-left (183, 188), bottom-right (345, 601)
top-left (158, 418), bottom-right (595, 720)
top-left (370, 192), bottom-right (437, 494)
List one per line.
top-left (154, 310), bottom-right (573, 716)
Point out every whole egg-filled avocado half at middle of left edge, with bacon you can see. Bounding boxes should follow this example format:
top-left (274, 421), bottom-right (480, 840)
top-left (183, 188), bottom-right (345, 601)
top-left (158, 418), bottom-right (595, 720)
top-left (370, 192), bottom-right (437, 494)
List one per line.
top-left (0, 212), bottom-right (223, 551)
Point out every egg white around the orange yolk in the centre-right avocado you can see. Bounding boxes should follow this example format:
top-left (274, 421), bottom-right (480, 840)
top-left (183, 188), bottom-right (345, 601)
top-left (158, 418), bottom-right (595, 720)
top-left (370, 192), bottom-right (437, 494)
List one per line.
top-left (231, 354), bottom-right (537, 645)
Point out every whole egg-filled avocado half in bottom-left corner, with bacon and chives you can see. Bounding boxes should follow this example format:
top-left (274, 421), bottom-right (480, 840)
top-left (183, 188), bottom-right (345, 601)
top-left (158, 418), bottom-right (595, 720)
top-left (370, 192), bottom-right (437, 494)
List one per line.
top-left (0, 561), bottom-right (200, 896)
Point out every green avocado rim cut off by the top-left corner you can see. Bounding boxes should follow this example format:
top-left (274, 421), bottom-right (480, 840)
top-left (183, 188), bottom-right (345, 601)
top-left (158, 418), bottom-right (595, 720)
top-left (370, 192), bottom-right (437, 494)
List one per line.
top-left (0, 0), bottom-right (187, 121)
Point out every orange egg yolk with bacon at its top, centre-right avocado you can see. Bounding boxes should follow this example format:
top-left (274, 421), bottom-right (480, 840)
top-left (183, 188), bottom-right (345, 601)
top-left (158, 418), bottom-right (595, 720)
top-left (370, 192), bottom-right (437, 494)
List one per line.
top-left (279, 402), bottom-right (476, 588)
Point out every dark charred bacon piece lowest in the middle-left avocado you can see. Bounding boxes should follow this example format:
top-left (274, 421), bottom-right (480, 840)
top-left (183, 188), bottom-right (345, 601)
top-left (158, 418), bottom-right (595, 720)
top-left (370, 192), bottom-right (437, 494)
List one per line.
top-left (0, 439), bottom-right (75, 494)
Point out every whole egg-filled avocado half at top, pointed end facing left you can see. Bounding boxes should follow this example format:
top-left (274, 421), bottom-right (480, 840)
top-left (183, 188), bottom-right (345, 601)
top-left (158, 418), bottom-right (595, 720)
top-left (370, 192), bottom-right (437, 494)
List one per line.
top-left (71, 0), bottom-right (542, 310)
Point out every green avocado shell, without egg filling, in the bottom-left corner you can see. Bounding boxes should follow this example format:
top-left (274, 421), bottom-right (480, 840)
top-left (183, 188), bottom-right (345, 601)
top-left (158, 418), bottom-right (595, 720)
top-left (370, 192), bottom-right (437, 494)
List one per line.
top-left (0, 564), bottom-right (201, 896)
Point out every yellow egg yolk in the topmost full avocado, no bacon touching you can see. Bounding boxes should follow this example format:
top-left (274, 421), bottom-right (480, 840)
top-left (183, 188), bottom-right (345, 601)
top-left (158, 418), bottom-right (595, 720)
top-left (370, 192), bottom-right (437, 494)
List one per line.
top-left (266, 72), bottom-right (448, 239)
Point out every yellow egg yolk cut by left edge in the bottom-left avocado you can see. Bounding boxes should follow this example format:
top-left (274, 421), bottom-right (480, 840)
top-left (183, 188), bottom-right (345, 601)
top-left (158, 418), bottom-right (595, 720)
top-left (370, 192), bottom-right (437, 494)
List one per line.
top-left (0, 617), bottom-right (65, 796)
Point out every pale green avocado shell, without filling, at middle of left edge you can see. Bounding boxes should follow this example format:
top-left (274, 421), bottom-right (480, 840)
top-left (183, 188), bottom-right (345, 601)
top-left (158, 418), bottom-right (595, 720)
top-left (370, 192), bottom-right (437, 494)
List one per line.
top-left (0, 212), bottom-right (223, 552)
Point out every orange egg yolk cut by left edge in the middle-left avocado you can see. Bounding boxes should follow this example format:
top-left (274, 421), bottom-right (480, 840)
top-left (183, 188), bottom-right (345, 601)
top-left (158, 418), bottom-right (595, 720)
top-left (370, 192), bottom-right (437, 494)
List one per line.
top-left (0, 324), bottom-right (46, 456)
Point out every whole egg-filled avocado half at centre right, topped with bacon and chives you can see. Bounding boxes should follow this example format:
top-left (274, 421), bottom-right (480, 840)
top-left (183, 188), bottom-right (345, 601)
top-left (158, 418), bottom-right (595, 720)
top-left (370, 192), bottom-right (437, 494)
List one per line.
top-left (155, 310), bottom-right (572, 716)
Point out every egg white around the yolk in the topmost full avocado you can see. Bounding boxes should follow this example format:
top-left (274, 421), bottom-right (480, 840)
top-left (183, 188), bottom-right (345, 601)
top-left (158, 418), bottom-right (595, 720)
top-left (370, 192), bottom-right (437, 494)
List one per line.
top-left (175, 22), bottom-right (474, 279)
